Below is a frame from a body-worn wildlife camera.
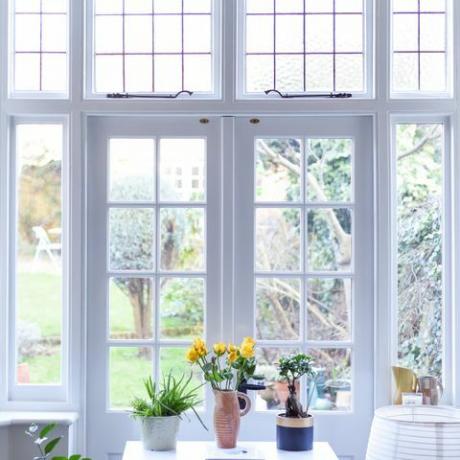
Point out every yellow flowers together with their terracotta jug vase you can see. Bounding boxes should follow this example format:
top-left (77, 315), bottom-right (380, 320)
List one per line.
top-left (187, 337), bottom-right (256, 449)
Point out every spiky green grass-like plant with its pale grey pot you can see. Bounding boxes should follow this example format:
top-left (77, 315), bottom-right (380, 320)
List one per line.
top-left (131, 372), bottom-right (207, 451)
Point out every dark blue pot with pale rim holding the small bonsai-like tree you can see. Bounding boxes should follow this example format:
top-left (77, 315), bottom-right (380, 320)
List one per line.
top-left (276, 414), bottom-right (313, 451)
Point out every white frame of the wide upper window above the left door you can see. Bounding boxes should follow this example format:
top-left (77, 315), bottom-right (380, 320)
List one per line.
top-left (86, 0), bottom-right (223, 99)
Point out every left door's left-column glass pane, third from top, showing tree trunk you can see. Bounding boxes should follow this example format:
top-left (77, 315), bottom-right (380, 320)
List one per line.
top-left (109, 278), bottom-right (154, 340)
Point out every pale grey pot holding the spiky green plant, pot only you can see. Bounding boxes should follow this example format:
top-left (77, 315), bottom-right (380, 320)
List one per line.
top-left (141, 416), bottom-right (180, 451)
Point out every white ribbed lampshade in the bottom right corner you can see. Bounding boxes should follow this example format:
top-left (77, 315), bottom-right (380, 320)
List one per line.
top-left (366, 406), bottom-right (460, 460)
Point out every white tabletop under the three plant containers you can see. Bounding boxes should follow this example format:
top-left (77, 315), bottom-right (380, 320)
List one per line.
top-left (123, 441), bottom-right (338, 460)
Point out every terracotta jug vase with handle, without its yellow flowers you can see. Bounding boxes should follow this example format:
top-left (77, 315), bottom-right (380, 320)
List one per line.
top-left (214, 390), bottom-right (251, 449)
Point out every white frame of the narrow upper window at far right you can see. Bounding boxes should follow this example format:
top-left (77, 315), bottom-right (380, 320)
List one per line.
top-left (388, 0), bottom-right (458, 99)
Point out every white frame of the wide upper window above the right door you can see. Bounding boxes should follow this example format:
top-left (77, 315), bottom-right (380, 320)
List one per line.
top-left (235, 0), bottom-right (376, 99)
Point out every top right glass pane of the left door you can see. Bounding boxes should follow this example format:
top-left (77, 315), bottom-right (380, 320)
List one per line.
top-left (160, 138), bottom-right (206, 201)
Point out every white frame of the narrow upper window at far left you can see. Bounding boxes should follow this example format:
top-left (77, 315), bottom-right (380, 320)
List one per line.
top-left (5, 0), bottom-right (72, 101)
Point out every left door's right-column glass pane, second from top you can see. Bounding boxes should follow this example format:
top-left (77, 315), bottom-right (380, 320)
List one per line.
top-left (160, 208), bottom-right (205, 271)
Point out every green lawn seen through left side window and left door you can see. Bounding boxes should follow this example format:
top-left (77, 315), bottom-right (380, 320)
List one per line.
top-left (18, 272), bottom-right (200, 398)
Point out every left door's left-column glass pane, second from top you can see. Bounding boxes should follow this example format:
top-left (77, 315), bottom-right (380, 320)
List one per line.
top-left (109, 208), bottom-right (155, 270)
